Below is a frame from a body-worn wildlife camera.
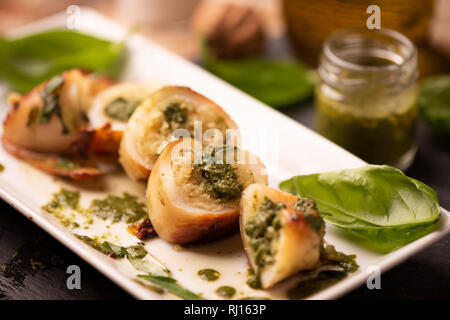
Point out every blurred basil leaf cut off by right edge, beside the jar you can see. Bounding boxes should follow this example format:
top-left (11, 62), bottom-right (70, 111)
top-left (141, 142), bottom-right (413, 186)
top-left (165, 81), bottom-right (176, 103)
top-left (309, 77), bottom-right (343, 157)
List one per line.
top-left (419, 75), bottom-right (450, 137)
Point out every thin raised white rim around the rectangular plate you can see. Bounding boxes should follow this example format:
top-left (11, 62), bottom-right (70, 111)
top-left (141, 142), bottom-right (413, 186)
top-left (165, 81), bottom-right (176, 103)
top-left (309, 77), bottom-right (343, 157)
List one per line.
top-left (0, 7), bottom-right (450, 300)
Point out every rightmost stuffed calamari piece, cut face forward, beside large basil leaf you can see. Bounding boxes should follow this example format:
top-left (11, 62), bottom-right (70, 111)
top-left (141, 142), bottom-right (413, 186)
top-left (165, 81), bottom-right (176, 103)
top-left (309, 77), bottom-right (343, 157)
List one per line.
top-left (240, 184), bottom-right (324, 289)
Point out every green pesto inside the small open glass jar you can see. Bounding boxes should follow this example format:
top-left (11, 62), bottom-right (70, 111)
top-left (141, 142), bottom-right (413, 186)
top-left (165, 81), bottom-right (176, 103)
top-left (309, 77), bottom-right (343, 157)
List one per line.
top-left (316, 85), bottom-right (418, 166)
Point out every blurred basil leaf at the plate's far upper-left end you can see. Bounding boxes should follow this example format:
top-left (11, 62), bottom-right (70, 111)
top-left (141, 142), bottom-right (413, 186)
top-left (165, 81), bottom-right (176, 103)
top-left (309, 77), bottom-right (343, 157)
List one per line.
top-left (0, 29), bottom-right (125, 93)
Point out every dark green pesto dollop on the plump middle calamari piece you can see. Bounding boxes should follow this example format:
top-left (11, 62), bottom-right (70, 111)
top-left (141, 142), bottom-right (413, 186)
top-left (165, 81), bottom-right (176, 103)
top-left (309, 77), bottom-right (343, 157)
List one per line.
top-left (194, 148), bottom-right (244, 201)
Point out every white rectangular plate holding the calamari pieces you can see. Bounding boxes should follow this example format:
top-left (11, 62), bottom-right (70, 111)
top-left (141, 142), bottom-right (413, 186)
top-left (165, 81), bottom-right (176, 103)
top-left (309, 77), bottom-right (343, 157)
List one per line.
top-left (0, 8), bottom-right (450, 299)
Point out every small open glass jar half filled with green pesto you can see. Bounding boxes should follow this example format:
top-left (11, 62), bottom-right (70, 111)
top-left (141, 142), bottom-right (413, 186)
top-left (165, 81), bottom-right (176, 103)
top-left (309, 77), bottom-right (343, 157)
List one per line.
top-left (316, 29), bottom-right (418, 169)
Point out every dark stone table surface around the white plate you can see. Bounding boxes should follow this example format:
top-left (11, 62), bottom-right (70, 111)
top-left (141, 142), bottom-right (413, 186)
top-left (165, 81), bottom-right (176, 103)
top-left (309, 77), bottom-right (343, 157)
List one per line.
top-left (0, 102), bottom-right (450, 299)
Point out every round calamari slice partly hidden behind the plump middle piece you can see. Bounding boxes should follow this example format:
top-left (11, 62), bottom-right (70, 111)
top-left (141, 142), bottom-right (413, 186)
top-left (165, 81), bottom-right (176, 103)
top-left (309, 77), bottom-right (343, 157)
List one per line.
top-left (120, 87), bottom-right (238, 181)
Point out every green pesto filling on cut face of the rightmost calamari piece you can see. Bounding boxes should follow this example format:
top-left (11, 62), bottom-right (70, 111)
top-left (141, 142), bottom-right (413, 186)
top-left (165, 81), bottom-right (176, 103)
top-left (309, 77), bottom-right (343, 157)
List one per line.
top-left (244, 197), bottom-right (286, 273)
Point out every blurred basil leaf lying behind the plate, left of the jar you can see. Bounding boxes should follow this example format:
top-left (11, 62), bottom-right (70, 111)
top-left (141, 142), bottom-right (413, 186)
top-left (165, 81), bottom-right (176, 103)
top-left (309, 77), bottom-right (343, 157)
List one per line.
top-left (203, 49), bottom-right (314, 108)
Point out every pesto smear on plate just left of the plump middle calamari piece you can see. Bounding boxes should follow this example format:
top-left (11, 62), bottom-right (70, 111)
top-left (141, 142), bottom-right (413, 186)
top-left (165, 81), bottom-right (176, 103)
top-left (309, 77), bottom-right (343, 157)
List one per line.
top-left (87, 192), bottom-right (147, 223)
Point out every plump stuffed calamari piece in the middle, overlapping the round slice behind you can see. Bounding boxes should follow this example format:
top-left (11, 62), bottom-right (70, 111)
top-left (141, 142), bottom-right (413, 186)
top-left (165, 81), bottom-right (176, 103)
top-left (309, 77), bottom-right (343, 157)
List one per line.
top-left (147, 139), bottom-right (267, 244)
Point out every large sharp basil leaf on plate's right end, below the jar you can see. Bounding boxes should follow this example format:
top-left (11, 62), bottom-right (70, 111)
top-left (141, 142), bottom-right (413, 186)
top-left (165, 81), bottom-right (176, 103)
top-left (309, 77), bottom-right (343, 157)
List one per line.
top-left (280, 165), bottom-right (440, 250)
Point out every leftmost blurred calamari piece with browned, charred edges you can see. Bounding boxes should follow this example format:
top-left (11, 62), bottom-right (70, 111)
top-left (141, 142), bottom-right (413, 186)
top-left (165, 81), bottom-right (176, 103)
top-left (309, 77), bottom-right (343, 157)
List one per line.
top-left (2, 69), bottom-right (121, 179)
